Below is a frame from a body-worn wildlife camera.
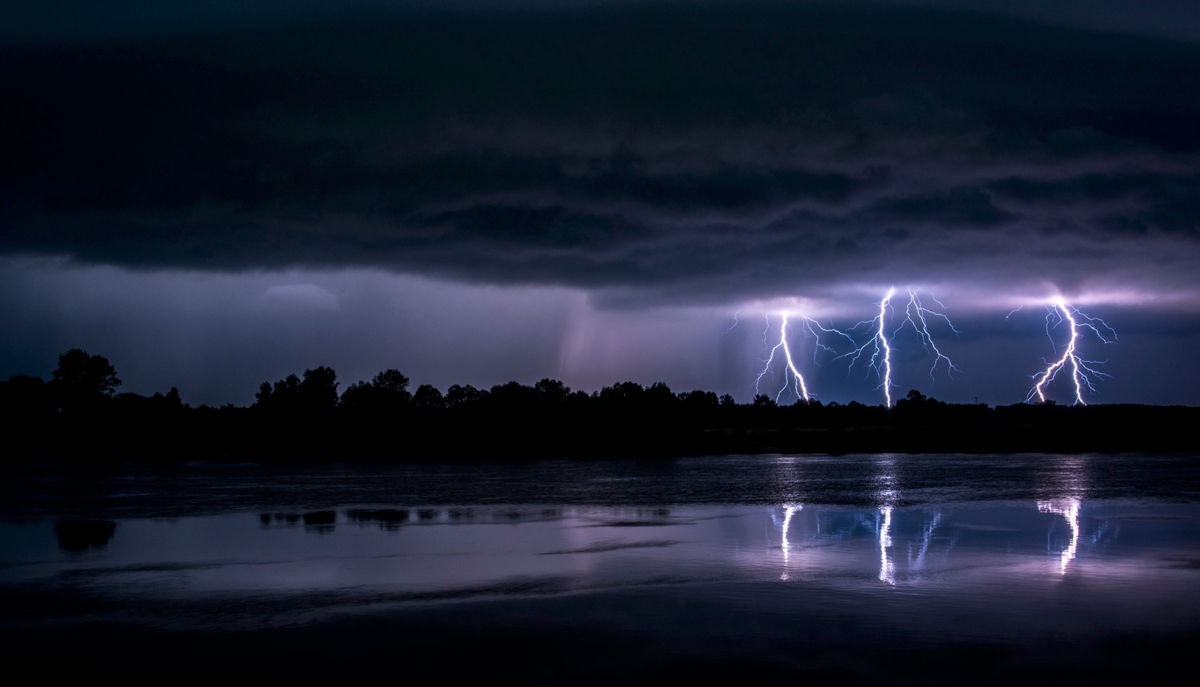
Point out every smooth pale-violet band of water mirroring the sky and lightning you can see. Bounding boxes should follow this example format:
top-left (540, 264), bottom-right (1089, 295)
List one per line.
top-left (0, 498), bottom-right (1200, 624)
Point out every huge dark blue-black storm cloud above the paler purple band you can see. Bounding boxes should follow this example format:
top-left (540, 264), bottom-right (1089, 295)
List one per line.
top-left (0, 4), bottom-right (1200, 304)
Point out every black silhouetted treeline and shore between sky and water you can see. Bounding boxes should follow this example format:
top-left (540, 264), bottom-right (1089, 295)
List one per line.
top-left (0, 348), bottom-right (1200, 460)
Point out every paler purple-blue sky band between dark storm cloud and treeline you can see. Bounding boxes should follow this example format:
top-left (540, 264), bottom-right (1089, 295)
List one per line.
top-left (0, 261), bottom-right (1200, 405)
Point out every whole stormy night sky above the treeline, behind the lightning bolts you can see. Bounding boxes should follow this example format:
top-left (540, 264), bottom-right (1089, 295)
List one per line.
top-left (0, 0), bottom-right (1200, 405)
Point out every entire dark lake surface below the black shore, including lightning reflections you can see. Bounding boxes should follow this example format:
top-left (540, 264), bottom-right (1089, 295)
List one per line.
top-left (0, 455), bottom-right (1200, 685)
